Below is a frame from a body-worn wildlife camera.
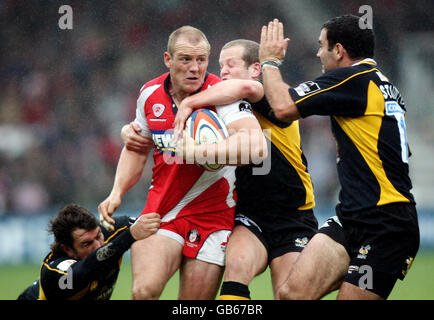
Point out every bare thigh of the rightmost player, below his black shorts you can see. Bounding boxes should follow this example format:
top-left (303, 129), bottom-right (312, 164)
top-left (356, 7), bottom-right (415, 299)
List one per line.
top-left (279, 233), bottom-right (350, 299)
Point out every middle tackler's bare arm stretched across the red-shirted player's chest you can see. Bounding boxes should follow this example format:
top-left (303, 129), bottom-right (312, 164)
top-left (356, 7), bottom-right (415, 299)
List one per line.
top-left (174, 79), bottom-right (264, 141)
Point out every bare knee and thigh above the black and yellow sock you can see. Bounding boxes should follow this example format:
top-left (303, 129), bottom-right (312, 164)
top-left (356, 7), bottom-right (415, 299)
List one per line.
top-left (225, 225), bottom-right (268, 284)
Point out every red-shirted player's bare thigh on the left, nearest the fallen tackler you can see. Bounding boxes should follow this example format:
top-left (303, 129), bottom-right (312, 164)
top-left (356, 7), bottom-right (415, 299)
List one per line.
top-left (131, 234), bottom-right (182, 292)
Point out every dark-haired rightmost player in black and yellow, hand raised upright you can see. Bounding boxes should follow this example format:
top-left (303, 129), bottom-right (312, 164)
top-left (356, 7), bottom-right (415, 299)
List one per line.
top-left (259, 15), bottom-right (419, 299)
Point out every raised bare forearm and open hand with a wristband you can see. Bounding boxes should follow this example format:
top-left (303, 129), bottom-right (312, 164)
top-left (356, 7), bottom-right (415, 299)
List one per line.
top-left (259, 19), bottom-right (300, 122)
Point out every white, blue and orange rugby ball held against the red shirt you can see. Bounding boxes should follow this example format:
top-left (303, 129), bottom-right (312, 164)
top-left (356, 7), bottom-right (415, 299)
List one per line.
top-left (185, 109), bottom-right (229, 172)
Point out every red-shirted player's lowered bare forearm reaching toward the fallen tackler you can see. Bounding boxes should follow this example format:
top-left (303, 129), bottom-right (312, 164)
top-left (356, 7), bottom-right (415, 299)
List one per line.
top-left (98, 147), bottom-right (150, 230)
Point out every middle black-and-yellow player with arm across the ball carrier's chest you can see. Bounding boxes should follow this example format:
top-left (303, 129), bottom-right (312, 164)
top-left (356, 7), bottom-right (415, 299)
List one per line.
top-left (175, 39), bottom-right (318, 300)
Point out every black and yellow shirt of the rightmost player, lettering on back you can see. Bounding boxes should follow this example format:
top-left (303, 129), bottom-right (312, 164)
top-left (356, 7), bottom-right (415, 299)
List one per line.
top-left (289, 59), bottom-right (414, 211)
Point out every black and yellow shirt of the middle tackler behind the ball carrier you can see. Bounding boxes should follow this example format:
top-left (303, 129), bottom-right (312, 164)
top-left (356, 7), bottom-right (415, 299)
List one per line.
top-left (235, 96), bottom-right (315, 215)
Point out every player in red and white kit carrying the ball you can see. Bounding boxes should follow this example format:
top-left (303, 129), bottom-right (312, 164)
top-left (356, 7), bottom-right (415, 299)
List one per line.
top-left (98, 26), bottom-right (266, 299)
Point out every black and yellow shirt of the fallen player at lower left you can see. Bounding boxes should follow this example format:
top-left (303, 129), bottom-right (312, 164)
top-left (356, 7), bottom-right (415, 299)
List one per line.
top-left (19, 216), bottom-right (135, 300)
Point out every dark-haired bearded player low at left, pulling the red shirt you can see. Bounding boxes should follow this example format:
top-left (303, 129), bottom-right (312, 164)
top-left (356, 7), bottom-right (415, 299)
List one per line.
top-left (18, 204), bottom-right (160, 300)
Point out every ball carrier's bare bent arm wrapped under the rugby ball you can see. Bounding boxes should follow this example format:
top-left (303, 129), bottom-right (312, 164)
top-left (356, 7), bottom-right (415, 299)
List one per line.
top-left (177, 116), bottom-right (268, 166)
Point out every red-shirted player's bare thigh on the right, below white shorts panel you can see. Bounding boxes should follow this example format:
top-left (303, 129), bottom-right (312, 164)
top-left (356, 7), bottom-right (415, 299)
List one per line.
top-left (178, 257), bottom-right (224, 300)
